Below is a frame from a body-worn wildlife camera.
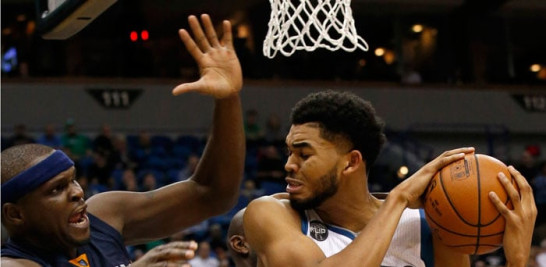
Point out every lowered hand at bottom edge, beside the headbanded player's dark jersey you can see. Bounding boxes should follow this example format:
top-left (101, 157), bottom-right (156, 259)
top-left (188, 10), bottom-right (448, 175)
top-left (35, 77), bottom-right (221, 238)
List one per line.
top-left (131, 241), bottom-right (197, 267)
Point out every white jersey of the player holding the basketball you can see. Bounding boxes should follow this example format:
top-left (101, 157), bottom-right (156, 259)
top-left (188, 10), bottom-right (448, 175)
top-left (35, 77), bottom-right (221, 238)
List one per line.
top-left (301, 209), bottom-right (434, 267)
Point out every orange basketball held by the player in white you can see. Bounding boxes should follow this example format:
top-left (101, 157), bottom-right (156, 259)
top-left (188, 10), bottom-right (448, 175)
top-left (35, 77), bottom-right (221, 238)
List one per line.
top-left (425, 154), bottom-right (517, 255)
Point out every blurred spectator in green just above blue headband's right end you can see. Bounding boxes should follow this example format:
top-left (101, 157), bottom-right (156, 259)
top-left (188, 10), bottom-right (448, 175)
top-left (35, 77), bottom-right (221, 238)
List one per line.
top-left (61, 119), bottom-right (91, 161)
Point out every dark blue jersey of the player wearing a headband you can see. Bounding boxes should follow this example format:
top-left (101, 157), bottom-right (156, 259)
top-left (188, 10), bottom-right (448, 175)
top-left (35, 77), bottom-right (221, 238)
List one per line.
top-left (2, 213), bottom-right (131, 267)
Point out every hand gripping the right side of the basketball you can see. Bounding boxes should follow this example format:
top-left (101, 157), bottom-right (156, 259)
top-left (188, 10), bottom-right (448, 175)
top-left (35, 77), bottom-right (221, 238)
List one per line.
top-left (489, 166), bottom-right (537, 266)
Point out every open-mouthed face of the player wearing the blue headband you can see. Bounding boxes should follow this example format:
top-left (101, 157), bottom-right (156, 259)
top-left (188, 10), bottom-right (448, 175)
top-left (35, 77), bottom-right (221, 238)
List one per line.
top-left (20, 167), bottom-right (90, 253)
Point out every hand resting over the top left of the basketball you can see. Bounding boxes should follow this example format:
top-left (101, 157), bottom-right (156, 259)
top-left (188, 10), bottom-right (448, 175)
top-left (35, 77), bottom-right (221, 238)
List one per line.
top-left (391, 147), bottom-right (474, 208)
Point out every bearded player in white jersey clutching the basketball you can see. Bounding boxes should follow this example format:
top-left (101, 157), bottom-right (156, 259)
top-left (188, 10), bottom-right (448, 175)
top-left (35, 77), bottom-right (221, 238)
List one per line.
top-left (243, 91), bottom-right (537, 267)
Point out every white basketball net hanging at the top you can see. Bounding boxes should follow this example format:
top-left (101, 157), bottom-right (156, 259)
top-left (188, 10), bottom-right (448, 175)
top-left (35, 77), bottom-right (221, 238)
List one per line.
top-left (263, 0), bottom-right (368, 58)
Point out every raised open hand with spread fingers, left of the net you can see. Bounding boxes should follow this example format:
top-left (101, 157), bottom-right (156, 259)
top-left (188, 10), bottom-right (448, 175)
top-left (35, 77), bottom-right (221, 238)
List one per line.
top-left (173, 14), bottom-right (243, 99)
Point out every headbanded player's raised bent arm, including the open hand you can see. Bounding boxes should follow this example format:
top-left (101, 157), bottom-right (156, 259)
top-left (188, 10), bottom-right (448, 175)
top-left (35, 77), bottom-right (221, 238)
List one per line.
top-left (87, 15), bottom-right (245, 244)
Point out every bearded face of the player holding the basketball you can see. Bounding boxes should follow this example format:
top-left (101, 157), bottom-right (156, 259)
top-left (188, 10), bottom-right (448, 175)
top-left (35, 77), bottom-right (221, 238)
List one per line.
top-left (285, 123), bottom-right (343, 209)
